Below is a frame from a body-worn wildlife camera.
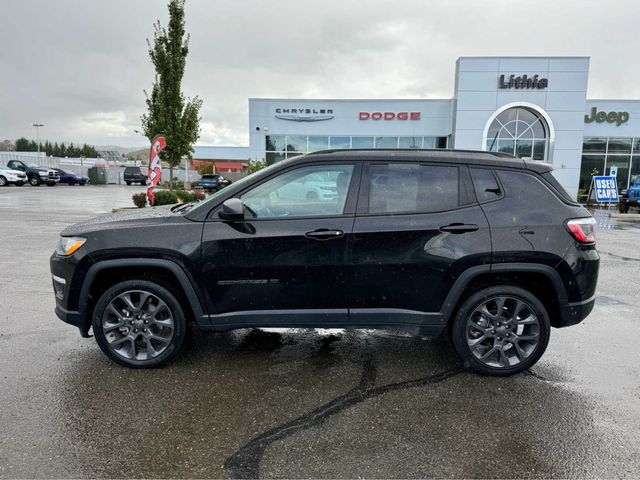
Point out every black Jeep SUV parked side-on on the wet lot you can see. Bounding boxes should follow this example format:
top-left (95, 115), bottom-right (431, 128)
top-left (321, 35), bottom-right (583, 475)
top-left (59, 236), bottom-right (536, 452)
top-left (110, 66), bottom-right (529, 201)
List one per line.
top-left (51, 150), bottom-right (599, 375)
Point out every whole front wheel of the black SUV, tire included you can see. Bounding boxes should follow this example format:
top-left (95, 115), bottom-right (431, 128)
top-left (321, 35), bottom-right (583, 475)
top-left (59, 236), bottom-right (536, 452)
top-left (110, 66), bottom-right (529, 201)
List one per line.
top-left (91, 280), bottom-right (187, 368)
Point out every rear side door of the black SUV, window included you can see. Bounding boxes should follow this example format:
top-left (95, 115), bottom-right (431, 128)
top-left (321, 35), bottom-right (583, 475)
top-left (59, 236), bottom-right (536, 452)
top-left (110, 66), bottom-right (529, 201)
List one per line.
top-left (349, 162), bottom-right (491, 324)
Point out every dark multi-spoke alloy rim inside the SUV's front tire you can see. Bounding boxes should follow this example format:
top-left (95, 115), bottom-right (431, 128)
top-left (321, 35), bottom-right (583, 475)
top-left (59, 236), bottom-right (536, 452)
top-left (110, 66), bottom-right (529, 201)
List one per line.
top-left (101, 290), bottom-right (175, 360)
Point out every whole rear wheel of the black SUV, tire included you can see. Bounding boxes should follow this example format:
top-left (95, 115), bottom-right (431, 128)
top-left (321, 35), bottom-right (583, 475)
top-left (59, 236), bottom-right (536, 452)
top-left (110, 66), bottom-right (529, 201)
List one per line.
top-left (451, 285), bottom-right (551, 377)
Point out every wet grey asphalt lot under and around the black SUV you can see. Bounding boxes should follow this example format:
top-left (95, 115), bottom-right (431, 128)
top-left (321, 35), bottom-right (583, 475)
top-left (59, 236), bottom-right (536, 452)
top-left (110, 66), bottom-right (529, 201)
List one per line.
top-left (0, 185), bottom-right (640, 478)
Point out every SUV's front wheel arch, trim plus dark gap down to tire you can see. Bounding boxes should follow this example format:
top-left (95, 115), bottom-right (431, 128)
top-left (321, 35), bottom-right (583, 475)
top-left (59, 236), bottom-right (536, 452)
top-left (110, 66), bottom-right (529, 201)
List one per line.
top-left (78, 258), bottom-right (205, 333)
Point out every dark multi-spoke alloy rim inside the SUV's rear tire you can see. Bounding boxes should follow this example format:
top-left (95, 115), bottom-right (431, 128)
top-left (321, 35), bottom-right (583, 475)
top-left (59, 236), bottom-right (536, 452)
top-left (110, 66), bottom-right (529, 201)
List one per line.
top-left (466, 296), bottom-right (541, 368)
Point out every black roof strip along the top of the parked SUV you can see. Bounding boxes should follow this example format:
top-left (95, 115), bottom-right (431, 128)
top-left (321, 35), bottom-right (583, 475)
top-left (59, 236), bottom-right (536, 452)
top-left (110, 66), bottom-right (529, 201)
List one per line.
top-left (287, 148), bottom-right (552, 173)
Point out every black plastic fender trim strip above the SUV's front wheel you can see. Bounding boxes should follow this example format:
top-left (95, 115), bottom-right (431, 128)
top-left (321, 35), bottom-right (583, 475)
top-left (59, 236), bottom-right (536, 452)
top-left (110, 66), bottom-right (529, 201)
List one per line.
top-left (78, 258), bottom-right (206, 321)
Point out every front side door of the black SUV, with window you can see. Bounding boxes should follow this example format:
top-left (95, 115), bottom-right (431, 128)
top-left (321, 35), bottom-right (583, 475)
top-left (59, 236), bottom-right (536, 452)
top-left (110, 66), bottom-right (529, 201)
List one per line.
top-left (201, 161), bottom-right (361, 325)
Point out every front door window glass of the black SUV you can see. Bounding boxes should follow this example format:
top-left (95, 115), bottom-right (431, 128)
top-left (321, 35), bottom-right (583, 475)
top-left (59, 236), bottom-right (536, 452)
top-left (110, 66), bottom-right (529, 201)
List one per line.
top-left (240, 165), bottom-right (353, 218)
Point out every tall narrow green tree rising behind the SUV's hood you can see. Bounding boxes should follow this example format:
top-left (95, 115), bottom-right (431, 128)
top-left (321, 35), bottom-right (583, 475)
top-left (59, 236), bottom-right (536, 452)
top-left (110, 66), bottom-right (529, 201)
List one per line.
top-left (140, 0), bottom-right (202, 188)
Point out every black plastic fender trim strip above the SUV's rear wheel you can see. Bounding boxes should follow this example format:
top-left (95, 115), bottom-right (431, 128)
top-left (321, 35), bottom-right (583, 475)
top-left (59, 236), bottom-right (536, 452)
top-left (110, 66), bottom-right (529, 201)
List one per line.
top-left (440, 263), bottom-right (568, 322)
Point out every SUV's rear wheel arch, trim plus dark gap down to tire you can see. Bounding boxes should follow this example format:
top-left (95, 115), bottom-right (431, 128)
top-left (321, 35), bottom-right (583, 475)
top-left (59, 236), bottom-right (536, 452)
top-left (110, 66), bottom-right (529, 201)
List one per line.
top-left (441, 263), bottom-right (568, 327)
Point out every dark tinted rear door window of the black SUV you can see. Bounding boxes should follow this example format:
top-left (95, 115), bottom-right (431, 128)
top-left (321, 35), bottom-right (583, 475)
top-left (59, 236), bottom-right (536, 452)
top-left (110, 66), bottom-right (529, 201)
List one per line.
top-left (369, 163), bottom-right (458, 214)
